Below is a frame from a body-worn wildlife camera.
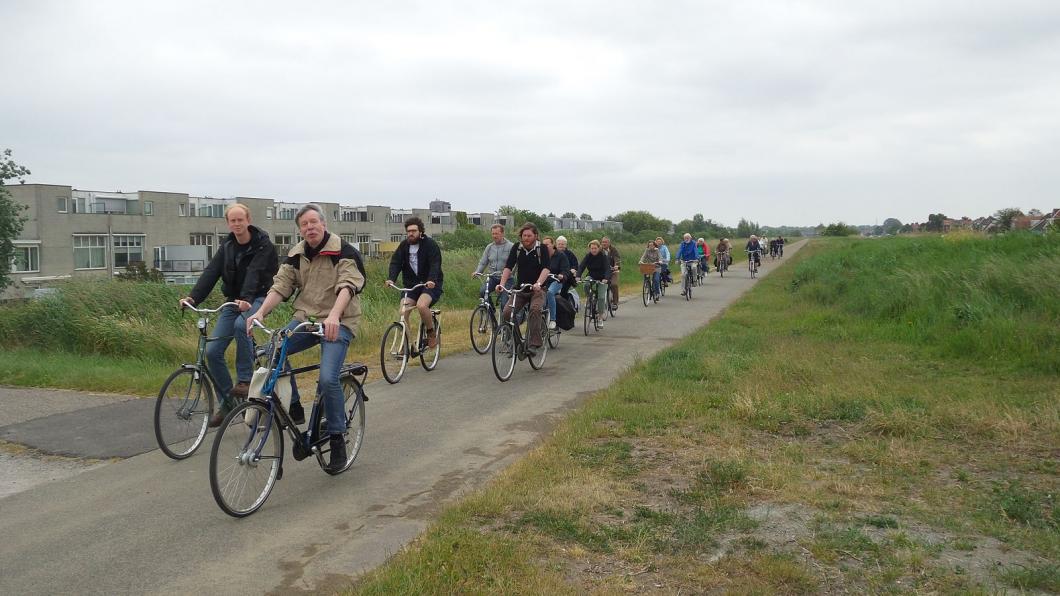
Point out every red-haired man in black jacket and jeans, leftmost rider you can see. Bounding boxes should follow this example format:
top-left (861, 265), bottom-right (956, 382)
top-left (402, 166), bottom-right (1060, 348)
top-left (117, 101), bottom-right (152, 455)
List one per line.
top-left (182, 203), bottom-right (280, 426)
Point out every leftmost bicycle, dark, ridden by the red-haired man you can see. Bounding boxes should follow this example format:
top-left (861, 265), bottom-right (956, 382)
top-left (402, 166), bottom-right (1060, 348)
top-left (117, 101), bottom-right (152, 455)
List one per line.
top-left (155, 300), bottom-right (260, 460)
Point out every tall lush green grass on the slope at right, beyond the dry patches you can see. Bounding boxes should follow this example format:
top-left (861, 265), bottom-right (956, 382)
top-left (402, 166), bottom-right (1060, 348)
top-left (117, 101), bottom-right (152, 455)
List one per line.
top-left (791, 233), bottom-right (1060, 373)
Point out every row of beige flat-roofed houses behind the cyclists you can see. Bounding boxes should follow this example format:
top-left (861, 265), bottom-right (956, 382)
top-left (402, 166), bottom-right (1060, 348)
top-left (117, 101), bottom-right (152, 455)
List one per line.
top-left (0, 183), bottom-right (621, 298)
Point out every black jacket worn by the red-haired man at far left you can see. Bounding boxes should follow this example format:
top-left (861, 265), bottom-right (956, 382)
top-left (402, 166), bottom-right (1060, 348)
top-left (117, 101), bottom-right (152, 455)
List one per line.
top-left (190, 226), bottom-right (280, 304)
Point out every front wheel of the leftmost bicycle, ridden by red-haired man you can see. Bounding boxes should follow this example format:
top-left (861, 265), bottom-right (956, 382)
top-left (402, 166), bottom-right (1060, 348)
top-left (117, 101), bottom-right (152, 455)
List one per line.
top-left (155, 368), bottom-right (213, 459)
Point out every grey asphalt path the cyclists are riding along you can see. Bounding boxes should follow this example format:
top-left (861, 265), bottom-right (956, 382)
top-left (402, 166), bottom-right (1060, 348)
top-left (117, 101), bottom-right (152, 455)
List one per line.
top-left (0, 243), bottom-right (801, 594)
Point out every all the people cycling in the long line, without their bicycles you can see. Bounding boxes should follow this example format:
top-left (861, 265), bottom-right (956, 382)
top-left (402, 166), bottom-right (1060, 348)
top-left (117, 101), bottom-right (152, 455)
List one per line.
top-left (181, 203), bottom-right (783, 470)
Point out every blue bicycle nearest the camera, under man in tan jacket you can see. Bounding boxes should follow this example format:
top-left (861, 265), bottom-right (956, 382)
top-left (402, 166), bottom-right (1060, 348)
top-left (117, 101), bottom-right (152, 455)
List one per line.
top-left (210, 320), bottom-right (368, 518)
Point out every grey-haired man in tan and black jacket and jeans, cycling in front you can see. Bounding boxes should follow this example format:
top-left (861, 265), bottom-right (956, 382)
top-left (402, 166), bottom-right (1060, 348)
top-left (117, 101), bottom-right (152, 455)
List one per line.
top-left (247, 203), bottom-right (365, 473)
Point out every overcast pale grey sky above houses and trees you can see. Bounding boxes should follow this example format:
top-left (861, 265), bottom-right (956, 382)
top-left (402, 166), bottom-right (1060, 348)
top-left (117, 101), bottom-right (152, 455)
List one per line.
top-left (0, 0), bottom-right (1060, 226)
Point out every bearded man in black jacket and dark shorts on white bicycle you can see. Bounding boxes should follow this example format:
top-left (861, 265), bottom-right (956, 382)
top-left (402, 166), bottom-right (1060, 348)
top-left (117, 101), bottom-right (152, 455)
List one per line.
top-left (386, 217), bottom-right (442, 350)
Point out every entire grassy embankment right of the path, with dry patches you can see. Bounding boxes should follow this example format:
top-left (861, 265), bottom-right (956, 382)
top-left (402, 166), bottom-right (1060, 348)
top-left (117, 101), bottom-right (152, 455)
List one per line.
top-left (356, 235), bottom-right (1060, 594)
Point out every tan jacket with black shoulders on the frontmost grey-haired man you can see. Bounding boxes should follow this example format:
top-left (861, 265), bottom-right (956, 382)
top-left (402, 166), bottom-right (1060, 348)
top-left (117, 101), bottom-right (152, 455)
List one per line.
top-left (269, 232), bottom-right (365, 336)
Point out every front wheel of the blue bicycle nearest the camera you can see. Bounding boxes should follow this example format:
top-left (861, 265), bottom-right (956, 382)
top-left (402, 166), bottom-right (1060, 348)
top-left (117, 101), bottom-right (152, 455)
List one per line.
top-left (210, 400), bottom-right (283, 518)
